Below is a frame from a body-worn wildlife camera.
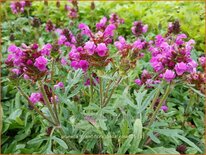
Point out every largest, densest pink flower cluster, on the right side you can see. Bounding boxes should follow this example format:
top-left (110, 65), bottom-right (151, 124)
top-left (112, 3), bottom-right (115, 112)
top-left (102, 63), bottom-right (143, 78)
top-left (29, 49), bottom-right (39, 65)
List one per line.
top-left (149, 34), bottom-right (197, 82)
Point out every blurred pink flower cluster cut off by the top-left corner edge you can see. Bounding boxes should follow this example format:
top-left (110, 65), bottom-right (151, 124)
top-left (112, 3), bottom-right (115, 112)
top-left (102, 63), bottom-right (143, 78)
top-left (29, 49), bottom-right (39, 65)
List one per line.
top-left (10, 1), bottom-right (31, 14)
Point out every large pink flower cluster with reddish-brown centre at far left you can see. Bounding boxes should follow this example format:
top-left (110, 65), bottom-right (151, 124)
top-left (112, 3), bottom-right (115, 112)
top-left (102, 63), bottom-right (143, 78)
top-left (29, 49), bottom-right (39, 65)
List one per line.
top-left (6, 44), bottom-right (52, 81)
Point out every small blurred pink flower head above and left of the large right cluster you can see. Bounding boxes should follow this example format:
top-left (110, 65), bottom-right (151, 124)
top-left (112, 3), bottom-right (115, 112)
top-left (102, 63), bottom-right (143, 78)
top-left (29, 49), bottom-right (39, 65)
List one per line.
top-left (131, 21), bottom-right (148, 36)
